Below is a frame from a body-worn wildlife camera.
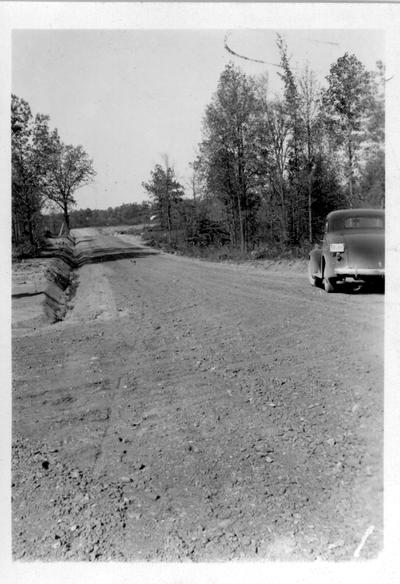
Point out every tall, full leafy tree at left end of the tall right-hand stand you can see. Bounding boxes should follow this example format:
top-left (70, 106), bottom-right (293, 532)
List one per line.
top-left (200, 64), bottom-right (259, 252)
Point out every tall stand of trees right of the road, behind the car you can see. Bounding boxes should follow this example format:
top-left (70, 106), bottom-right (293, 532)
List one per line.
top-left (143, 37), bottom-right (385, 252)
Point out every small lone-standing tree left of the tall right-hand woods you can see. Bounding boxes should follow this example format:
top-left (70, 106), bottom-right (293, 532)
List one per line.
top-left (142, 155), bottom-right (184, 245)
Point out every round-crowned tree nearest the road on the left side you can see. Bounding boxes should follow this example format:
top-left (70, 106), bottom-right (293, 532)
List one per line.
top-left (36, 126), bottom-right (96, 231)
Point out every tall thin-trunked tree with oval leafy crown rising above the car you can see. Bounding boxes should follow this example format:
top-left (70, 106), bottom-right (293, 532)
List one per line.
top-left (323, 53), bottom-right (372, 205)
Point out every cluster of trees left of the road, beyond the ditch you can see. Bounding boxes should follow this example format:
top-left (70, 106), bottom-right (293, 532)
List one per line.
top-left (11, 95), bottom-right (96, 249)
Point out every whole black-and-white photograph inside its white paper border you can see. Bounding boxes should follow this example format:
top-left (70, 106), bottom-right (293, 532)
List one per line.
top-left (3, 4), bottom-right (396, 582)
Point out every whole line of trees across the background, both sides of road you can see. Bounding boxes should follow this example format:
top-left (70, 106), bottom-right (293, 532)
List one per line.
top-left (11, 36), bottom-right (385, 253)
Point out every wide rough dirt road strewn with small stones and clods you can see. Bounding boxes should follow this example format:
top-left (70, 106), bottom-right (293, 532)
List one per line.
top-left (12, 232), bottom-right (384, 561)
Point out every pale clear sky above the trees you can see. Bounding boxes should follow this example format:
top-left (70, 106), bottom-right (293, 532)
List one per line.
top-left (12, 29), bottom-right (385, 209)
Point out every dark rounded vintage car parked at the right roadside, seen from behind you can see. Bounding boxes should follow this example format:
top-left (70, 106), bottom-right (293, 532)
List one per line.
top-left (308, 209), bottom-right (385, 292)
